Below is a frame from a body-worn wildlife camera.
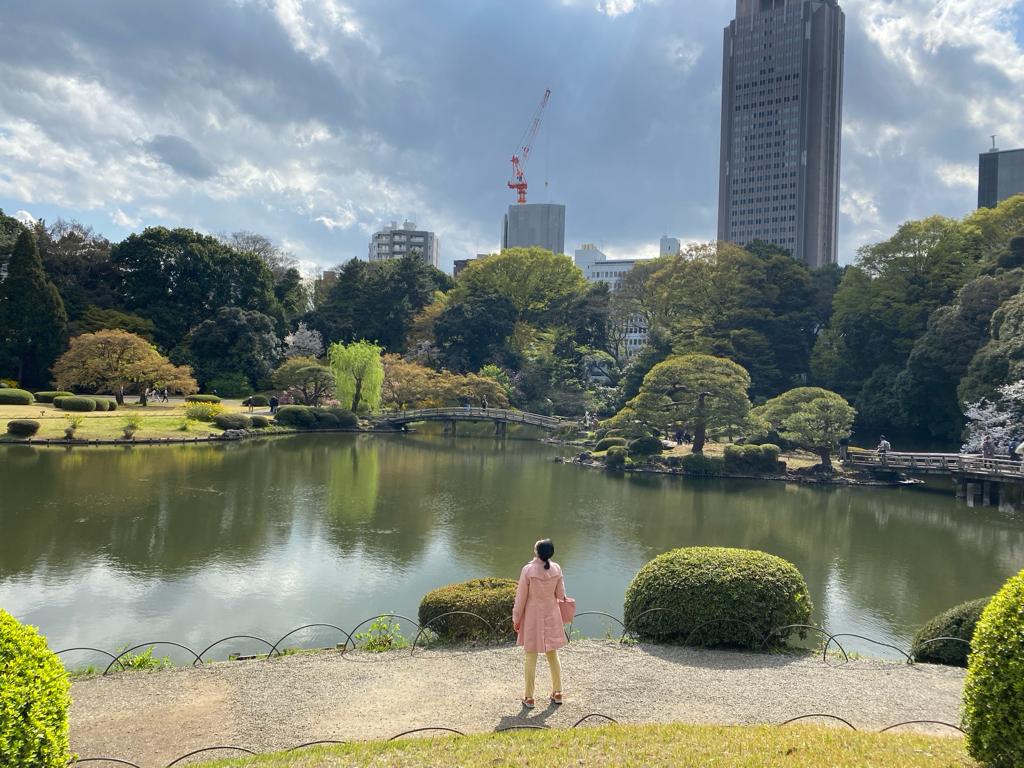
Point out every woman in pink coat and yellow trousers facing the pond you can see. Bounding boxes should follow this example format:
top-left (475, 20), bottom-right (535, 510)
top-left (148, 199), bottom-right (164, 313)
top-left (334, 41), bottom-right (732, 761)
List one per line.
top-left (512, 539), bottom-right (565, 709)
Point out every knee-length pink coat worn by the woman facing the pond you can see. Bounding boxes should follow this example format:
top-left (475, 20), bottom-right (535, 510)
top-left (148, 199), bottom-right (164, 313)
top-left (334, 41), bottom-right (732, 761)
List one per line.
top-left (512, 557), bottom-right (565, 653)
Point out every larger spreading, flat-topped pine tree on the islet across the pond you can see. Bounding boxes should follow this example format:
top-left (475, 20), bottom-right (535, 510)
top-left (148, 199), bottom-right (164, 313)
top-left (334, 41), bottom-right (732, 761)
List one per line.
top-left (627, 354), bottom-right (751, 454)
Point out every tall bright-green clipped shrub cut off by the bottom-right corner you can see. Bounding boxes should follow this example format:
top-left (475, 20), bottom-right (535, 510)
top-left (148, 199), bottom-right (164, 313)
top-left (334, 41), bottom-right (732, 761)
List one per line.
top-left (964, 570), bottom-right (1024, 768)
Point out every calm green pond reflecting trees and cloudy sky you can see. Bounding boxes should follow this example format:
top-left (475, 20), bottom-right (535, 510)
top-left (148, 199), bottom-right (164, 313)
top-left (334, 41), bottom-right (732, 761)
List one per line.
top-left (0, 433), bottom-right (1024, 666)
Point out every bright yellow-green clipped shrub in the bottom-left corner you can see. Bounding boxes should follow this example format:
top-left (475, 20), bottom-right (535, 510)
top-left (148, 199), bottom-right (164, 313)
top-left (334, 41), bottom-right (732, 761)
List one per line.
top-left (0, 609), bottom-right (71, 768)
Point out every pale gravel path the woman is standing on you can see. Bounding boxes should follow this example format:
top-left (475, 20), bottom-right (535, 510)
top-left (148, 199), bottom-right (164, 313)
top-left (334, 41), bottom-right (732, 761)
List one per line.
top-left (71, 641), bottom-right (964, 768)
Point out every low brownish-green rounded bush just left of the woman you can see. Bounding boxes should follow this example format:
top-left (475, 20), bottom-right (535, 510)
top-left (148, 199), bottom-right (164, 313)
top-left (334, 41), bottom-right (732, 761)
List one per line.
top-left (419, 579), bottom-right (516, 642)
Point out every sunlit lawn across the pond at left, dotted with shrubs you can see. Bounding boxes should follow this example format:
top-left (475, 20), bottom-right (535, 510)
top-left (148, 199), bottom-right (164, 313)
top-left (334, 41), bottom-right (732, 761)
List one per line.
top-left (0, 397), bottom-right (268, 441)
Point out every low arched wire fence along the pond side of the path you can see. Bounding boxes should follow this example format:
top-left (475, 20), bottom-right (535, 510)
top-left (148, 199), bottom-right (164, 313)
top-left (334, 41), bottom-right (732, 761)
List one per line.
top-left (55, 607), bottom-right (971, 676)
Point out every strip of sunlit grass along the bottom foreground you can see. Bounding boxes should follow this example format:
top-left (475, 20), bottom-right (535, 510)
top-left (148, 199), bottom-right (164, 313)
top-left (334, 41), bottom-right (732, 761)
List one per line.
top-left (195, 717), bottom-right (977, 768)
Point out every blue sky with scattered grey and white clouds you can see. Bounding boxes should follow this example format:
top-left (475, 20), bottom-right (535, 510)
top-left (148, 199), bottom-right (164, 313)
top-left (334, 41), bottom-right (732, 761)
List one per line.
top-left (0, 0), bottom-right (1024, 268)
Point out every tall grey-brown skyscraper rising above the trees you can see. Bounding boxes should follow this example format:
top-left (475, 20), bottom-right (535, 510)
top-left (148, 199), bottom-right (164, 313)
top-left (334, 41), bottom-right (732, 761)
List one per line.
top-left (718, 0), bottom-right (846, 267)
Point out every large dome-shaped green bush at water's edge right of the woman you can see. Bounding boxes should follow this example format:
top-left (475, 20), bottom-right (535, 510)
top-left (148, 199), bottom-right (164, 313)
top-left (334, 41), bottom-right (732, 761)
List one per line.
top-left (624, 547), bottom-right (811, 650)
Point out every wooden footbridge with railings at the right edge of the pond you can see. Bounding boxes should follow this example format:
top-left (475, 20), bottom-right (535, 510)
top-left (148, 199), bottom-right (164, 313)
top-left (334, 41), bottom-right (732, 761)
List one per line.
top-left (843, 451), bottom-right (1024, 508)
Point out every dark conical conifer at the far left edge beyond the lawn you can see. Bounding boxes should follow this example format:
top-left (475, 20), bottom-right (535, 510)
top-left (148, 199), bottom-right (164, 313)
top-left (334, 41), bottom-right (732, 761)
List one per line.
top-left (0, 229), bottom-right (68, 386)
